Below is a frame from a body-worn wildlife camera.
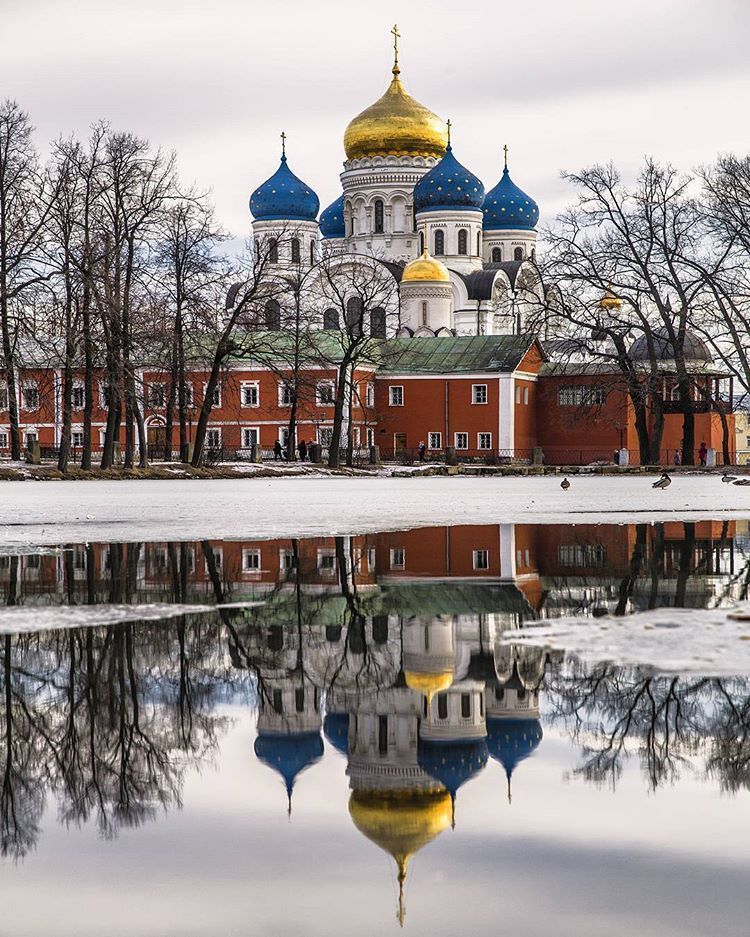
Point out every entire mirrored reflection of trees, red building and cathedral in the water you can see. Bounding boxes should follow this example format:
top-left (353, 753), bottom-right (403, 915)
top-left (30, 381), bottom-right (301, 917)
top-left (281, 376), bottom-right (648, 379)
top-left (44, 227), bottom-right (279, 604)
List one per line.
top-left (0, 522), bottom-right (750, 924)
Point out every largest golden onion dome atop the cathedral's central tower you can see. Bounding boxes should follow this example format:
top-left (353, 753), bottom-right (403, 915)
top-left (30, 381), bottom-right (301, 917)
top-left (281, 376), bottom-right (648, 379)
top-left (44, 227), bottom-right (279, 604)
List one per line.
top-left (344, 65), bottom-right (448, 159)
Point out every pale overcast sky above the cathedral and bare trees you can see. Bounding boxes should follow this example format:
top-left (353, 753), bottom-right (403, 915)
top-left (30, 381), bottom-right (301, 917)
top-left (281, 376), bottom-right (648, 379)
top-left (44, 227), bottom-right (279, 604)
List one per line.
top-left (0, 0), bottom-right (750, 236)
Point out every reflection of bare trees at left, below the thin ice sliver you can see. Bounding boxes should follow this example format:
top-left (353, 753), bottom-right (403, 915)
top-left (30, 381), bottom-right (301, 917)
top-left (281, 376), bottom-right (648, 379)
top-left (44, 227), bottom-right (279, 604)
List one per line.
top-left (0, 545), bottom-right (236, 857)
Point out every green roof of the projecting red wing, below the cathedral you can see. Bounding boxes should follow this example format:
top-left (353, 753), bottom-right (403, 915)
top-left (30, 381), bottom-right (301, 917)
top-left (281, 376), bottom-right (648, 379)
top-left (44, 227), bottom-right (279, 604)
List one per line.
top-left (380, 335), bottom-right (536, 374)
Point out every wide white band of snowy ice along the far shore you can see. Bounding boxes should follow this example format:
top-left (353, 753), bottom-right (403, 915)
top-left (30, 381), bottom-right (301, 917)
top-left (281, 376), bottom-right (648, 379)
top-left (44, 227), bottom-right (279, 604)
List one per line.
top-left (0, 474), bottom-right (750, 547)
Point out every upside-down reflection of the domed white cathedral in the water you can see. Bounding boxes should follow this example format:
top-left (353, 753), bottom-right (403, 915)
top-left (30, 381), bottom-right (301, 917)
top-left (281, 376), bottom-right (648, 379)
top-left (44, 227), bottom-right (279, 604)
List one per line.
top-left (245, 590), bottom-right (546, 922)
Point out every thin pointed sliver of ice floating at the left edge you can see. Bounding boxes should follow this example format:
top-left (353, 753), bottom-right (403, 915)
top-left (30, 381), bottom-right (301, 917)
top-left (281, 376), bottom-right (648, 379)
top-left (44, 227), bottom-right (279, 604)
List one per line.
top-left (0, 602), bottom-right (261, 634)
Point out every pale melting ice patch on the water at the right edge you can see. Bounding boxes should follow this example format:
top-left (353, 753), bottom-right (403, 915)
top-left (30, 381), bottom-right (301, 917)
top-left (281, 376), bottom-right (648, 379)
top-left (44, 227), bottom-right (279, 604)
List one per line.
top-left (503, 606), bottom-right (750, 677)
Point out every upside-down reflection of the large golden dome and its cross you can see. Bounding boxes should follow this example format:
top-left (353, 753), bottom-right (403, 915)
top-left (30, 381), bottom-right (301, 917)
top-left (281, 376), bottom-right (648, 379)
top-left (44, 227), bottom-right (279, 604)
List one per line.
top-left (349, 788), bottom-right (453, 924)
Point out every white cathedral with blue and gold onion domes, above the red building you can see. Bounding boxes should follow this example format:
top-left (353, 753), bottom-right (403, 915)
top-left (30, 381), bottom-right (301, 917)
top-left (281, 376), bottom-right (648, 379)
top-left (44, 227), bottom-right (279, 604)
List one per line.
top-left (250, 27), bottom-right (551, 338)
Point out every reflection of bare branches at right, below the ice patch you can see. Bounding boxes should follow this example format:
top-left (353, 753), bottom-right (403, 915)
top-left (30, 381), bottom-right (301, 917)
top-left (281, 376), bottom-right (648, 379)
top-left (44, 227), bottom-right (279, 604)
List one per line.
top-left (545, 661), bottom-right (750, 790)
